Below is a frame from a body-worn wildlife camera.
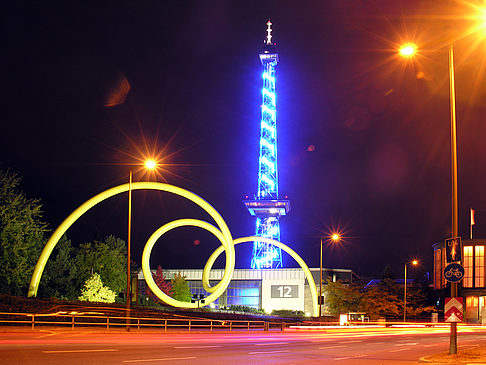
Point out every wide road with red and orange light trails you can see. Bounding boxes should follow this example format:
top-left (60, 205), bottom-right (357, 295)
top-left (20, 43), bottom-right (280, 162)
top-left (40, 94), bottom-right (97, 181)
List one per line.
top-left (0, 326), bottom-right (486, 365)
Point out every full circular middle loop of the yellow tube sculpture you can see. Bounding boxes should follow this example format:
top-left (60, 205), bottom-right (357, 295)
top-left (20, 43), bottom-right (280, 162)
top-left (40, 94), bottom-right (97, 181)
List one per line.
top-left (142, 219), bottom-right (234, 308)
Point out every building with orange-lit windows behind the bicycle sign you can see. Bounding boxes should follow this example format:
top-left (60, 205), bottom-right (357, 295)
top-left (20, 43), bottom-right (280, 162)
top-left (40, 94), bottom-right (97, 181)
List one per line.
top-left (433, 239), bottom-right (486, 323)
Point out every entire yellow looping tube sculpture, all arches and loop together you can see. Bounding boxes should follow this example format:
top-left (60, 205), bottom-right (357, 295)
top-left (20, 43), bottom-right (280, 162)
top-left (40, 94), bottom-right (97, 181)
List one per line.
top-left (27, 182), bottom-right (318, 315)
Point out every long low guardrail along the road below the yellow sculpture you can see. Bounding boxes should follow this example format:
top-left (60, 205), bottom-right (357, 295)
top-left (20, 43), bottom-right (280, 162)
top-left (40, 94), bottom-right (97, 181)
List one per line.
top-left (0, 313), bottom-right (285, 332)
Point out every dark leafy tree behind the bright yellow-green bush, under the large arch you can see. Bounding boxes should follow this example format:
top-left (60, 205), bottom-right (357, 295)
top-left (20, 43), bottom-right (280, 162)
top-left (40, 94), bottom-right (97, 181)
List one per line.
top-left (71, 236), bottom-right (127, 293)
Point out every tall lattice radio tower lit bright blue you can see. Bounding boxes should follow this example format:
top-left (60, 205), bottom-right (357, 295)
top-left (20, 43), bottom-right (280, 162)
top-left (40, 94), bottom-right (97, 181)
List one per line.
top-left (243, 20), bottom-right (290, 269)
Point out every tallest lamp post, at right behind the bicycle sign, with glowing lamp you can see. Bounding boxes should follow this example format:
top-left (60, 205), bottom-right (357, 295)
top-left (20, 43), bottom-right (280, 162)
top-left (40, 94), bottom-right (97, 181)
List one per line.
top-left (399, 42), bottom-right (458, 355)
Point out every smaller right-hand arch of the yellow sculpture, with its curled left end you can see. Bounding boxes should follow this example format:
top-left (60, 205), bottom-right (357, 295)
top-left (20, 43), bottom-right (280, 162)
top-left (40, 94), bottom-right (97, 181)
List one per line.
top-left (202, 236), bottom-right (319, 316)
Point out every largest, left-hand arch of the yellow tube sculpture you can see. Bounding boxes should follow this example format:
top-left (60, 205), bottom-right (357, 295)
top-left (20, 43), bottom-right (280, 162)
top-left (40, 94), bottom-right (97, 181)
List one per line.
top-left (27, 182), bottom-right (235, 297)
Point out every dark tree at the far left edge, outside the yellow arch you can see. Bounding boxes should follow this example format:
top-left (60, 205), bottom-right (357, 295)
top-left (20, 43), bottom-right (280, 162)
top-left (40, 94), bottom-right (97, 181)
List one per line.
top-left (0, 171), bottom-right (47, 295)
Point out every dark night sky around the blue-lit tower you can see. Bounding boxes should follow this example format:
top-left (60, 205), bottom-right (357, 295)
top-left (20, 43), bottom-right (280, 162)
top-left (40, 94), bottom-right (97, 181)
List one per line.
top-left (0, 0), bottom-right (486, 277)
